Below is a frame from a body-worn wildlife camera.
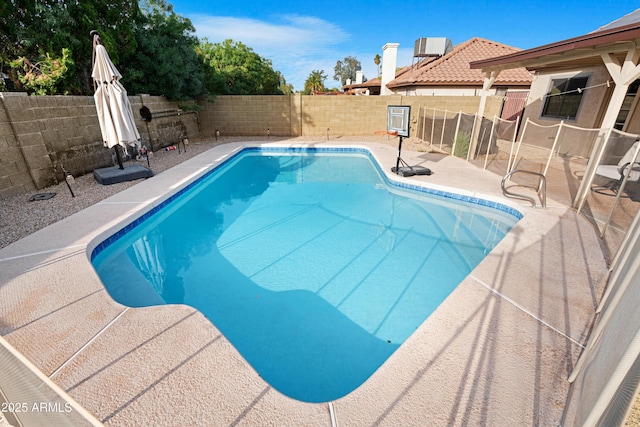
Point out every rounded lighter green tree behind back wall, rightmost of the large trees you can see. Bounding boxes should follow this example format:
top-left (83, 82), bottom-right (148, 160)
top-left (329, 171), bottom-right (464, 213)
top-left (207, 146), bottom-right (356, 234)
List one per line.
top-left (198, 39), bottom-right (286, 95)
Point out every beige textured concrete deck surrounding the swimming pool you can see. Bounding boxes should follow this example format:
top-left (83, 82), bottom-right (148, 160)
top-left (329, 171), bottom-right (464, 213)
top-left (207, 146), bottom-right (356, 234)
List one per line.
top-left (0, 142), bottom-right (607, 426)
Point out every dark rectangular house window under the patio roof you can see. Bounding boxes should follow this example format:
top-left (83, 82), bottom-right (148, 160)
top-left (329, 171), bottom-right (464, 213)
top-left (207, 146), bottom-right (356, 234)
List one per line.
top-left (542, 76), bottom-right (589, 119)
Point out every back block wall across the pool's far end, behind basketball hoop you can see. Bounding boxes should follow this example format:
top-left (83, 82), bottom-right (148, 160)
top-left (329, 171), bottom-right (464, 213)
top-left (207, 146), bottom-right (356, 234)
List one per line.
top-left (200, 94), bottom-right (502, 137)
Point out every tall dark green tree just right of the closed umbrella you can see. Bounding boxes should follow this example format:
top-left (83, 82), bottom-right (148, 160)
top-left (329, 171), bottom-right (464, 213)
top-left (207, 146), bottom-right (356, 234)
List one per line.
top-left (120, 0), bottom-right (205, 100)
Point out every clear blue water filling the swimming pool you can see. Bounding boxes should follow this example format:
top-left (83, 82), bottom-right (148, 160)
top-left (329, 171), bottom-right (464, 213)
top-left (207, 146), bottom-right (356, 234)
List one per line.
top-left (92, 149), bottom-right (520, 402)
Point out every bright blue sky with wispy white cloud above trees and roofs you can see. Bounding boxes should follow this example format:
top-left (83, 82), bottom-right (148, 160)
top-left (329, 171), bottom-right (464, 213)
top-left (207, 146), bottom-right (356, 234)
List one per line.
top-left (169, 0), bottom-right (640, 90)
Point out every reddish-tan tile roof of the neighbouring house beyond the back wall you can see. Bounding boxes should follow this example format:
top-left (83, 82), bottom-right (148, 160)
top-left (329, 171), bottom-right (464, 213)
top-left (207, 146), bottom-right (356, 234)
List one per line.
top-left (387, 37), bottom-right (532, 88)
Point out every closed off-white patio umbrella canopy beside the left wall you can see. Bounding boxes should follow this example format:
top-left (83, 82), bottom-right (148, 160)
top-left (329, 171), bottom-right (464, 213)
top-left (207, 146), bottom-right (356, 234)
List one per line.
top-left (91, 34), bottom-right (140, 153)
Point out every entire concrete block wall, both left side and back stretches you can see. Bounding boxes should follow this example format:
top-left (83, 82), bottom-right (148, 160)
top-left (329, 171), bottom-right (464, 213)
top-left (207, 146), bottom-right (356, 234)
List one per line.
top-left (0, 93), bottom-right (502, 199)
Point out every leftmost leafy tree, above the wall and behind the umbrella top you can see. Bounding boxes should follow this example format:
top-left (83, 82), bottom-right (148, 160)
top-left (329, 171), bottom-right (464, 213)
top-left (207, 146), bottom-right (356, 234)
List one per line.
top-left (0, 0), bottom-right (141, 94)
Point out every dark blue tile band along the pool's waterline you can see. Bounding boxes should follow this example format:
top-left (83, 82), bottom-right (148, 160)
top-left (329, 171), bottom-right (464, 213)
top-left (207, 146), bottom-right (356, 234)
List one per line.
top-left (90, 147), bottom-right (523, 262)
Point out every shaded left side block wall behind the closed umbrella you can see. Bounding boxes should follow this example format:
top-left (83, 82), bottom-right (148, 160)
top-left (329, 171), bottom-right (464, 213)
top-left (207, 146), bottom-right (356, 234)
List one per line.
top-left (0, 92), bottom-right (192, 199)
